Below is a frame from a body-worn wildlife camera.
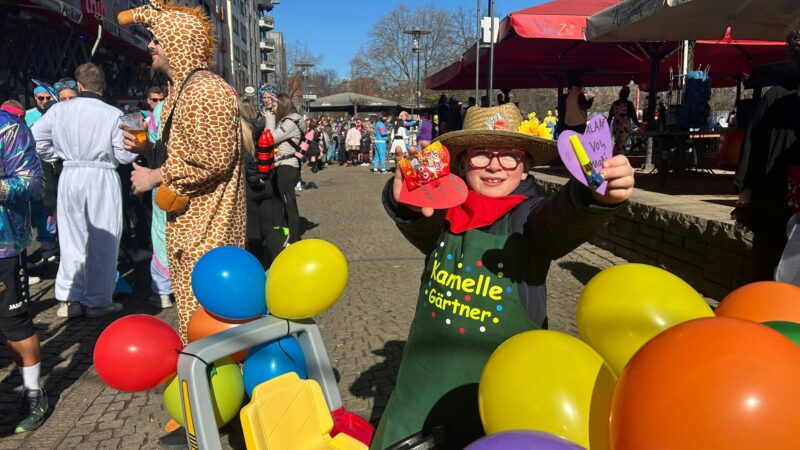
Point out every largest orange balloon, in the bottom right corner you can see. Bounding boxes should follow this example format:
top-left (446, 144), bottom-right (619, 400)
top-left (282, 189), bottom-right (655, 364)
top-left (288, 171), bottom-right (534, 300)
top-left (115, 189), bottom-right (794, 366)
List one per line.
top-left (610, 317), bottom-right (800, 450)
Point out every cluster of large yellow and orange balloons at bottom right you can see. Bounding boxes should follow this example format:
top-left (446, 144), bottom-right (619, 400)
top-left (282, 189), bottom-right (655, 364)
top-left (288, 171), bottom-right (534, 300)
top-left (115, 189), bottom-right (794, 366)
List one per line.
top-left (468, 264), bottom-right (800, 450)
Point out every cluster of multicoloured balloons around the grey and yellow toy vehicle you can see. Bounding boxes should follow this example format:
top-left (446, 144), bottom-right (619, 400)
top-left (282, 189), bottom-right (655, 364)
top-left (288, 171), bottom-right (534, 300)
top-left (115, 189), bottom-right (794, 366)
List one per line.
top-left (94, 239), bottom-right (347, 427)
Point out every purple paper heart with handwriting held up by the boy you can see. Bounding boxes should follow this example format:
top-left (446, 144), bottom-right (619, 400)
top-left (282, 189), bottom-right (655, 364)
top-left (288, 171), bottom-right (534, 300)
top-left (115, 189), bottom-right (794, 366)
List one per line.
top-left (558, 114), bottom-right (614, 195)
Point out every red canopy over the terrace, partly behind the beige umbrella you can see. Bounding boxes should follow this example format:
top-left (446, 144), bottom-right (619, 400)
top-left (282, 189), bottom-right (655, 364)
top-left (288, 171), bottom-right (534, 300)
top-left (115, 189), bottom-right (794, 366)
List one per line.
top-left (425, 0), bottom-right (785, 90)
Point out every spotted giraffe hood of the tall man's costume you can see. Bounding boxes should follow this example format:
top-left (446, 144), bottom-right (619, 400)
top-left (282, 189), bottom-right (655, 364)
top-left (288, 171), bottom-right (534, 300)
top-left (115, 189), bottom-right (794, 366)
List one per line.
top-left (117, 0), bottom-right (216, 86)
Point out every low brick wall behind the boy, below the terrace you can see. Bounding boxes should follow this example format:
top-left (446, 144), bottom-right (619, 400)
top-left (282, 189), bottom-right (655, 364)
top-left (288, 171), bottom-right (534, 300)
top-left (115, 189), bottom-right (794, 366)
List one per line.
top-left (537, 179), bottom-right (752, 300)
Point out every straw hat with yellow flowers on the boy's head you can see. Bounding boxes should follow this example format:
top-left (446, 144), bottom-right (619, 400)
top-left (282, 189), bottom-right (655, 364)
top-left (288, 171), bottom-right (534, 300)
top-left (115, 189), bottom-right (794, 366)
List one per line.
top-left (436, 103), bottom-right (558, 166)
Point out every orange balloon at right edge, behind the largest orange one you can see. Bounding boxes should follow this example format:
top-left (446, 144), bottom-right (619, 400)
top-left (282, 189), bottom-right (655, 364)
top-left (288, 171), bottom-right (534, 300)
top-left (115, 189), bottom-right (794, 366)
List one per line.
top-left (716, 281), bottom-right (800, 323)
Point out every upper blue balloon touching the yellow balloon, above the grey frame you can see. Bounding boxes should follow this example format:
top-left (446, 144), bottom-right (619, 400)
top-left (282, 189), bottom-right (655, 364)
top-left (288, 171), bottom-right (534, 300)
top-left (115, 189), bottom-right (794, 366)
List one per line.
top-left (192, 247), bottom-right (267, 320)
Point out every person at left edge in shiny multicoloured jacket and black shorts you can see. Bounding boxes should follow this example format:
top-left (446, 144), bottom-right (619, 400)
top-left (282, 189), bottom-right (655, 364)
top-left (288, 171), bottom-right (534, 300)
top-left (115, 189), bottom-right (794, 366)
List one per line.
top-left (0, 100), bottom-right (48, 433)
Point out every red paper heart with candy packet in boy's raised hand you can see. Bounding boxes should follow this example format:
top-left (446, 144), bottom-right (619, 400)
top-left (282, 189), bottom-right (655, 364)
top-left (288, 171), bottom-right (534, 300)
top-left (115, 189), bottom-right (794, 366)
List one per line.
top-left (397, 142), bottom-right (467, 209)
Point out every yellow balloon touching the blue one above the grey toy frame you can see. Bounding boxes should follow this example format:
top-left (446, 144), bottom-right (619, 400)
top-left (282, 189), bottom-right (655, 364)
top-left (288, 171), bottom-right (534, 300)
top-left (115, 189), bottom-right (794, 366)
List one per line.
top-left (266, 239), bottom-right (347, 320)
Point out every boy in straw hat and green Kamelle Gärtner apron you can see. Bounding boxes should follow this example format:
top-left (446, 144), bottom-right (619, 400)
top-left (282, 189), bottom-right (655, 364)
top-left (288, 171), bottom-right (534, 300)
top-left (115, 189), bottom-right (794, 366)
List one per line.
top-left (371, 103), bottom-right (633, 449)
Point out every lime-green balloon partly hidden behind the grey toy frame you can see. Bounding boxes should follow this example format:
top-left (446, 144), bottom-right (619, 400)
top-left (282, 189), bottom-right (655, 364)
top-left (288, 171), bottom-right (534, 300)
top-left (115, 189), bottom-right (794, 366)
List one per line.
top-left (164, 358), bottom-right (244, 428)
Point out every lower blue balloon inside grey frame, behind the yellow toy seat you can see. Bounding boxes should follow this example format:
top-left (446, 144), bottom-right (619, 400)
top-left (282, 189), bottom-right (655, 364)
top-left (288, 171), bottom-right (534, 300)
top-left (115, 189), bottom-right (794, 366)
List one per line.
top-left (242, 336), bottom-right (308, 398)
